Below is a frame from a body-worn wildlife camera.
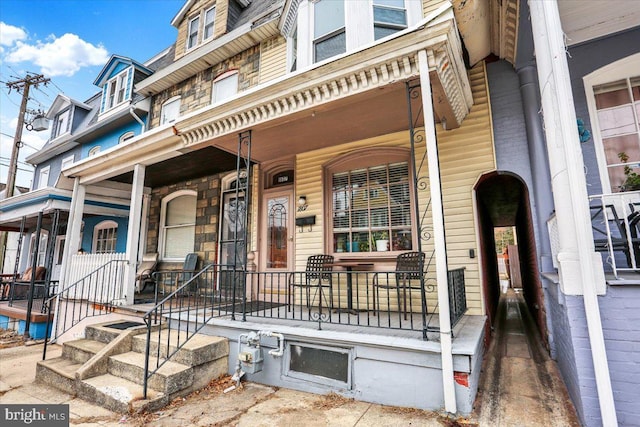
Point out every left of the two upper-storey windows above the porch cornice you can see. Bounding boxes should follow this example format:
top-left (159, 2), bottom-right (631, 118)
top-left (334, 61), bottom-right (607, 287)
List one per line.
top-left (313, 0), bottom-right (347, 62)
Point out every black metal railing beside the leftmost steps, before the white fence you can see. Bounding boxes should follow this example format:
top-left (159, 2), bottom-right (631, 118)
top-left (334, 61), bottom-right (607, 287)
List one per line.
top-left (42, 260), bottom-right (127, 360)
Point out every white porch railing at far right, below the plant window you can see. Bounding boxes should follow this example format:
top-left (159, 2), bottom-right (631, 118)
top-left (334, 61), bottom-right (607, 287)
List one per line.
top-left (589, 191), bottom-right (640, 277)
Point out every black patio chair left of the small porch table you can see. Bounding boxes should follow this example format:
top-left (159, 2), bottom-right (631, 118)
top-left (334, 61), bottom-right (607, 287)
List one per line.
top-left (288, 255), bottom-right (333, 311)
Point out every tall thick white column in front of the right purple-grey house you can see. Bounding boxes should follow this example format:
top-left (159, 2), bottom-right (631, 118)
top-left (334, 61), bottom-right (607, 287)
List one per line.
top-left (529, 1), bottom-right (617, 426)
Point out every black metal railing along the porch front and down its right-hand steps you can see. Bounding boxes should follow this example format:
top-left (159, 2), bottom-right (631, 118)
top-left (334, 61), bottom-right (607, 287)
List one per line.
top-left (144, 264), bottom-right (466, 397)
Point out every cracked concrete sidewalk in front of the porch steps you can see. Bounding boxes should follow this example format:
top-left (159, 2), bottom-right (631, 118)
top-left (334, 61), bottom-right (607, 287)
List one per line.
top-left (0, 344), bottom-right (466, 427)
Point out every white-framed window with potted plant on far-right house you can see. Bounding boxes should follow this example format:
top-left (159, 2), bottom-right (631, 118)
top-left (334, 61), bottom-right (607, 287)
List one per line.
top-left (584, 54), bottom-right (640, 192)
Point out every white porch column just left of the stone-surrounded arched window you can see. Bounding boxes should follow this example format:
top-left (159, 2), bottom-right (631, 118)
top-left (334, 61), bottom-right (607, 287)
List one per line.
top-left (124, 164), bottom-right (146, 304)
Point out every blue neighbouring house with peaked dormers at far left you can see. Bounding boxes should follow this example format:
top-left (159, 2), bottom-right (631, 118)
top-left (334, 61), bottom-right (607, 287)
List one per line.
top-left (0, 56), bottom-right (152, 332)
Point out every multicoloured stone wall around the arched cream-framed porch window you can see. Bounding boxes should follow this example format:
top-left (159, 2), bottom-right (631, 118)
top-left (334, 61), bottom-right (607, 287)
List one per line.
top-left (147, 175), bottom-right (220, 269)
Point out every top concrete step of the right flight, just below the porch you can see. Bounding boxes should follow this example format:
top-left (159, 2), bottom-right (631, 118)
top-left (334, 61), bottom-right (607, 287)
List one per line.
top-left (132, 329), bottom-right (229, 366)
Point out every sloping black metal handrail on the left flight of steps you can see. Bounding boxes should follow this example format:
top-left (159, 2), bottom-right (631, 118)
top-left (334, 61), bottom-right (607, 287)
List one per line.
top-left (42, 260), bottom-right (127, 360)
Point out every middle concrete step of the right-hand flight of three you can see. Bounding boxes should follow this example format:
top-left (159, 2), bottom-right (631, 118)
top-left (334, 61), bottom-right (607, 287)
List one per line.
top-left (109, 351), bottom-right (194, 395)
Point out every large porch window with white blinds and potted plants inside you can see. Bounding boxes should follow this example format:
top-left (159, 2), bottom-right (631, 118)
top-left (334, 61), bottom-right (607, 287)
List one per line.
top-left (332, 162), bottom-right (413, 252)
